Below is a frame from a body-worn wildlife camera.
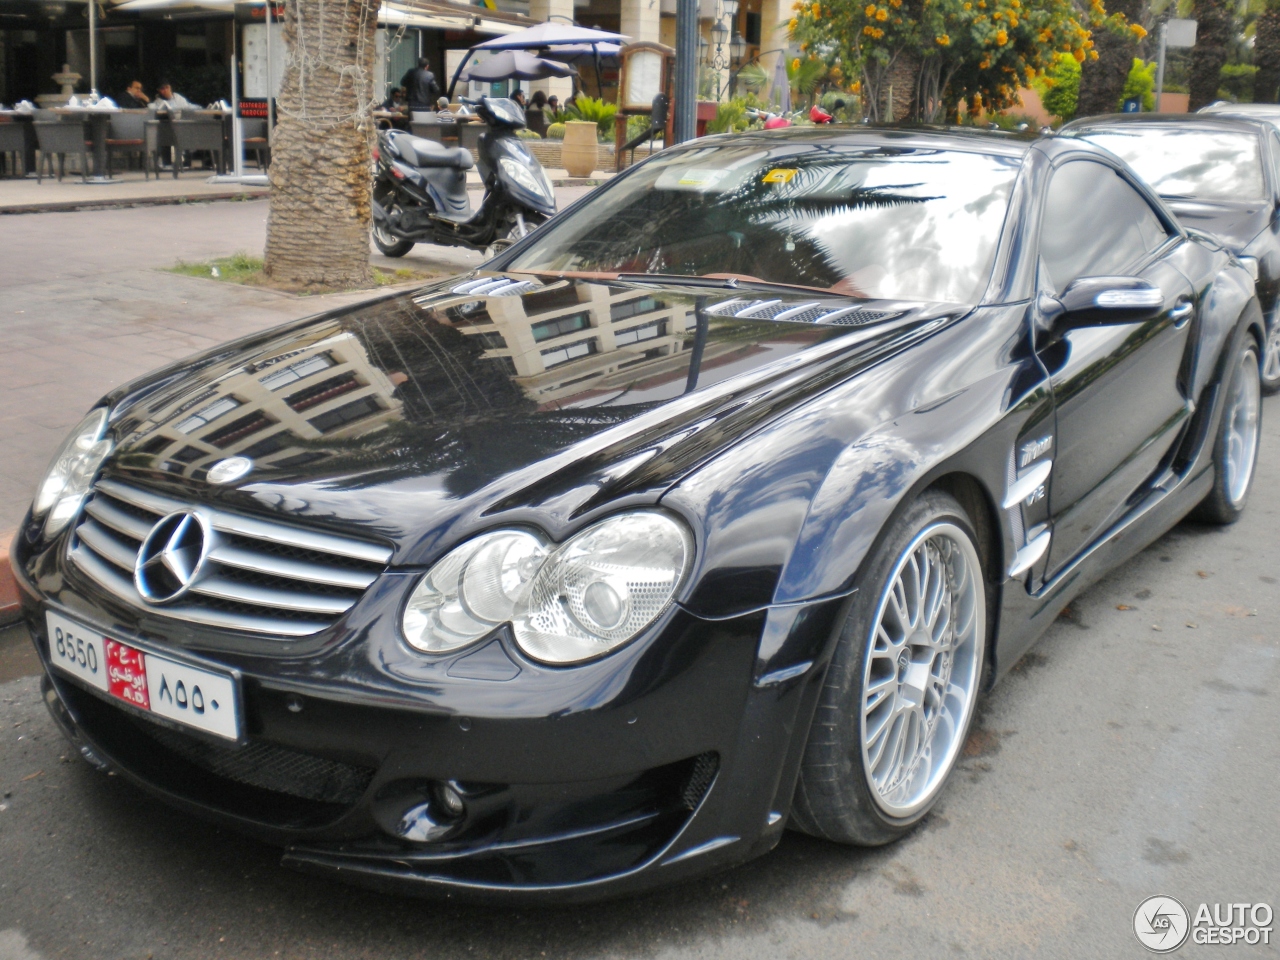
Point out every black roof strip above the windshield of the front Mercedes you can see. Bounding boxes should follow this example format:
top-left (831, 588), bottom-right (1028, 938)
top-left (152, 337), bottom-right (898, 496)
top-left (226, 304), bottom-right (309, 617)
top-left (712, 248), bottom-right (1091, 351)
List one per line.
top-left (681, 123), bottom-right (1037, 157)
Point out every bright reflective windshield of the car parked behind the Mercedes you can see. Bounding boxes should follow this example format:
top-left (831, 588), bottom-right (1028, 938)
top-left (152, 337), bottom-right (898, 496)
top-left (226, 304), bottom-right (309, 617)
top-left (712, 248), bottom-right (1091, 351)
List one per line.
top-left (1080, 124), bottom-right (1262, 200)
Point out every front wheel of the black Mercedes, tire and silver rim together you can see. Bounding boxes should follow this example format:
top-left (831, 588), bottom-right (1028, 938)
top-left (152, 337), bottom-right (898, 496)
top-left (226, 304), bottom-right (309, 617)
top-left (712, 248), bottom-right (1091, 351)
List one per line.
top-left (792, 490), bottom-right (987, 846)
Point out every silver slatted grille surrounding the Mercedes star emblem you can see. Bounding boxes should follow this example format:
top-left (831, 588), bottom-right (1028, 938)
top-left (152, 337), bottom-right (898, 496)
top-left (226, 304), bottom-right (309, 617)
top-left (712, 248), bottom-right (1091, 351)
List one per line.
top-left (70, 480), bottom-right (392, 637)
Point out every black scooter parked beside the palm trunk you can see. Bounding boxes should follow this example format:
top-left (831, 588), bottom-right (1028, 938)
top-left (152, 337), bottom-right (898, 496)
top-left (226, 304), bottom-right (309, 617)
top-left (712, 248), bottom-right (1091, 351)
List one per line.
top-left (372, 97), bottom-right (556, 257)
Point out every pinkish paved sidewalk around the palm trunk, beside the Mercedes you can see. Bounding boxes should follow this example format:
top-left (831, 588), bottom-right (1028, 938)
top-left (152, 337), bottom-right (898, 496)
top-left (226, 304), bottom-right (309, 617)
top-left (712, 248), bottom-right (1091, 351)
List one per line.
top-left (0, 187), bottom-right (589, 529)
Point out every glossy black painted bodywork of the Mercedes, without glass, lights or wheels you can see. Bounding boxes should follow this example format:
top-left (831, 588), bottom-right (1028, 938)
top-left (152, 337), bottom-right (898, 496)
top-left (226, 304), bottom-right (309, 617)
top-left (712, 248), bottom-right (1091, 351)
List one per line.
top-left (13, 128), bottom-right (1261, 900)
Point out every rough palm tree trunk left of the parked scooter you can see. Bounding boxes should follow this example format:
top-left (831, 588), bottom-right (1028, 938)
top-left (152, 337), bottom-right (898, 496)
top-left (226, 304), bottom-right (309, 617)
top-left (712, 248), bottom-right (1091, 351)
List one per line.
top-left (265, 0), bottom-right (378, 288)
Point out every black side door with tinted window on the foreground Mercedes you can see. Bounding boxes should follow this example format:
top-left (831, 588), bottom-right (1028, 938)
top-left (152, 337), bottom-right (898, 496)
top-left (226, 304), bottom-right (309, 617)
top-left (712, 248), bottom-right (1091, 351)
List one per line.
top-left (1037, 160), bottom-right (1196, 576)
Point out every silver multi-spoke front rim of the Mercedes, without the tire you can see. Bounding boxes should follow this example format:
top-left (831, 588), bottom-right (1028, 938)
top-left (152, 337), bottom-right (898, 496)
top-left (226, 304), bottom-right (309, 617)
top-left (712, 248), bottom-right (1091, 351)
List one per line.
top-left (861, 522), bottom-right (987, 817)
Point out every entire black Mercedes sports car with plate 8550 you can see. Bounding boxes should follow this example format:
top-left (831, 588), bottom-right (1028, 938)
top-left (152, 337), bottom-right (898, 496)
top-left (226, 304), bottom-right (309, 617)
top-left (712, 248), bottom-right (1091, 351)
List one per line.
top-left (13, 128), bottom-right (1263, 899)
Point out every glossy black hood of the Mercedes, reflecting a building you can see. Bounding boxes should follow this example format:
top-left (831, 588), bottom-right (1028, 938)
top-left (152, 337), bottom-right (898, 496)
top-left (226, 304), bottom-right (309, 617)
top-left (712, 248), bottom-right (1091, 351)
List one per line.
top-left (106, 274), bottom-right (969, 564)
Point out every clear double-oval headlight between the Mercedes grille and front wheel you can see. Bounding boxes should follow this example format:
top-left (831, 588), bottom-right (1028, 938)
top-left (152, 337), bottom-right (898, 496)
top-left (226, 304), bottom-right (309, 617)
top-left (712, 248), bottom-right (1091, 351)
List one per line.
top-left (403, 511), bottom-right (694, 663)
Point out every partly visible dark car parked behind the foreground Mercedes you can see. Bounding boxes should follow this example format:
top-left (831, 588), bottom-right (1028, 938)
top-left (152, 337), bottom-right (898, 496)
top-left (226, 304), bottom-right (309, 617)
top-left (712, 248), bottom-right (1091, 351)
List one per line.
top-left (1061, 113), bottom-right (1280, 393)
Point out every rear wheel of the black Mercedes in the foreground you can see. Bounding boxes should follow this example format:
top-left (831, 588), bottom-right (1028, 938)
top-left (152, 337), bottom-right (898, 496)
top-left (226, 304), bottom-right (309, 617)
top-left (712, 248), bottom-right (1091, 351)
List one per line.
top-left (1192, 330), bottom-right (1262, 525)
